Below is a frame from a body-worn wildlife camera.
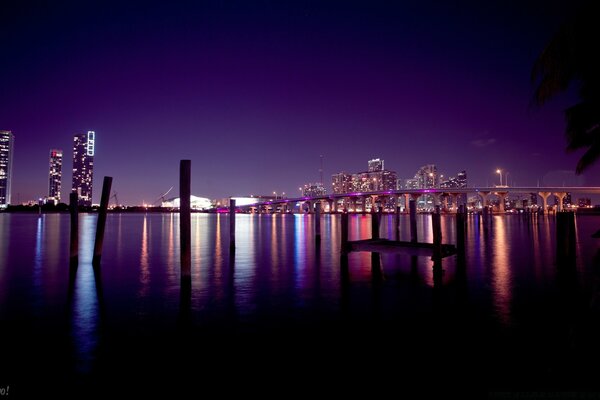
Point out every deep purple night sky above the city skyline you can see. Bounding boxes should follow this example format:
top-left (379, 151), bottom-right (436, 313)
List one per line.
top-left (0, 0), bottom-right (600, 204)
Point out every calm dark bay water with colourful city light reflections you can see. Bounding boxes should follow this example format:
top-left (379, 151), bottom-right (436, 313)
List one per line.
top-left (0, 214), bottom-right (600, 397)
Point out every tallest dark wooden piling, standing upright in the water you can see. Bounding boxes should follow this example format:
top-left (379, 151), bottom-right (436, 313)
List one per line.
top-left (179, 160), bottom-right (192, 280)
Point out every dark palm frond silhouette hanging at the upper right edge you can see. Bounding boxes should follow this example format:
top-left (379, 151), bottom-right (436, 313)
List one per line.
top-left (532, 1), bottom-right (600, 174)
